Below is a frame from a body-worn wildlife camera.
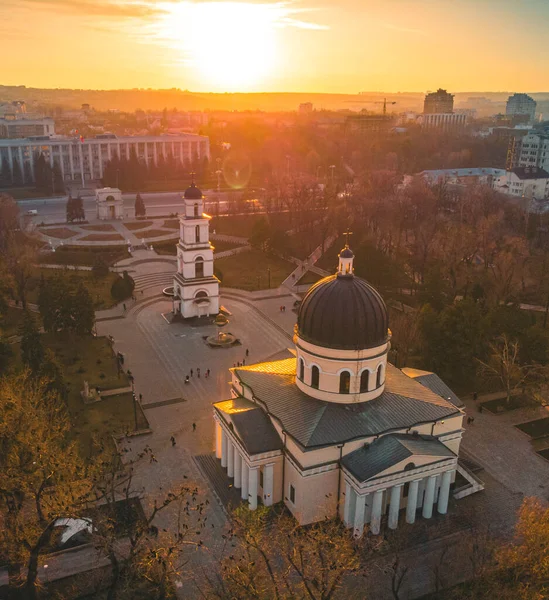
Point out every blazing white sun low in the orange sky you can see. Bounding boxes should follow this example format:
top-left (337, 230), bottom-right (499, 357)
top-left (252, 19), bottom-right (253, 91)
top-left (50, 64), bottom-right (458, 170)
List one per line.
top-left (158, 2), bottom-right (280, 91)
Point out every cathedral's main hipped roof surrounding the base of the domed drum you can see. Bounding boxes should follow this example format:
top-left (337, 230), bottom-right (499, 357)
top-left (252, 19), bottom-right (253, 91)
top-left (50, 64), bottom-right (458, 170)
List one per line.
top-left (231, 358), bottom-right (460, 448)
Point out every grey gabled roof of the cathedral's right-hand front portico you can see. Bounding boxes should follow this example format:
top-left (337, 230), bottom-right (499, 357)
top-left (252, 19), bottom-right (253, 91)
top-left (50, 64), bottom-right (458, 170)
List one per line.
top-left (341, 434), bottom-right (455, 482)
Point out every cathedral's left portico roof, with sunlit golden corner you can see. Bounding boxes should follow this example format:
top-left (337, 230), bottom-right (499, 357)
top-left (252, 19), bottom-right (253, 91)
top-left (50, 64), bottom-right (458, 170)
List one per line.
top-left (214, 398), bottom-right (282, 455)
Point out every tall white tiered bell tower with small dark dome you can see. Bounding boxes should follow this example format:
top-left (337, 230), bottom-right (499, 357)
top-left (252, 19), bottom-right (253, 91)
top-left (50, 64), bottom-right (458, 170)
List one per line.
top-left (173, 183), bottom-right (219, 319)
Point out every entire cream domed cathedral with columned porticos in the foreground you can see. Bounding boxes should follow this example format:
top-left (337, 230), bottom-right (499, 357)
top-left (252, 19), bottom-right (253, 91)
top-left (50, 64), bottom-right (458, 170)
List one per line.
top-left (213, 246), bottom-right (482, 537)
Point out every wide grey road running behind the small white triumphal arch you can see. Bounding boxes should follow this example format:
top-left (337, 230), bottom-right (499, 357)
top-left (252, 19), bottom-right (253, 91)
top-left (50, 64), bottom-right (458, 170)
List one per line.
top-left (17, 190), bottom-right (228, 224)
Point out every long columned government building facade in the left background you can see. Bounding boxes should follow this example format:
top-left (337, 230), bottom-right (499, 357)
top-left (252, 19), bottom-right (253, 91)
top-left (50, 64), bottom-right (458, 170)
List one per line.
top-left (0, 133), bottom-right (210, 186)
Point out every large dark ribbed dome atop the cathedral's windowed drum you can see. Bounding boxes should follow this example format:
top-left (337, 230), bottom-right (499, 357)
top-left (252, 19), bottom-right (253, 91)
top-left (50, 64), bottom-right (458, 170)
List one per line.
top-left (297, 274), bottom-right (389, 350)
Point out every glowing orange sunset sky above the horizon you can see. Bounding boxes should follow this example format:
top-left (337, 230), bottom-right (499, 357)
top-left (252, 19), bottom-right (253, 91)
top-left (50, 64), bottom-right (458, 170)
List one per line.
top-left (0, 0), bottom-right (549, 93)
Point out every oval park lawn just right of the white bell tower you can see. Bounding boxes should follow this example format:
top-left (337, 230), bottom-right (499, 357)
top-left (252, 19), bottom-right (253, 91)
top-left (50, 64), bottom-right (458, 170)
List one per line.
top-left (215, 250), bottom-right (294, 292)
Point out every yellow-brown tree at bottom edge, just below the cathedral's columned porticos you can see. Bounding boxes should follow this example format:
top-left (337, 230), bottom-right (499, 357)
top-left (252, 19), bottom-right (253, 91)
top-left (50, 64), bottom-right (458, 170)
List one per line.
top-left (207, 507), bottom-right (364, 600)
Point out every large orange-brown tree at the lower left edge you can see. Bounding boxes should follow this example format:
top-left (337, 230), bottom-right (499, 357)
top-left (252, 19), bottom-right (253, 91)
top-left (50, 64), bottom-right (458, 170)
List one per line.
top-left (0, 373), bottom-right (94, 600)
